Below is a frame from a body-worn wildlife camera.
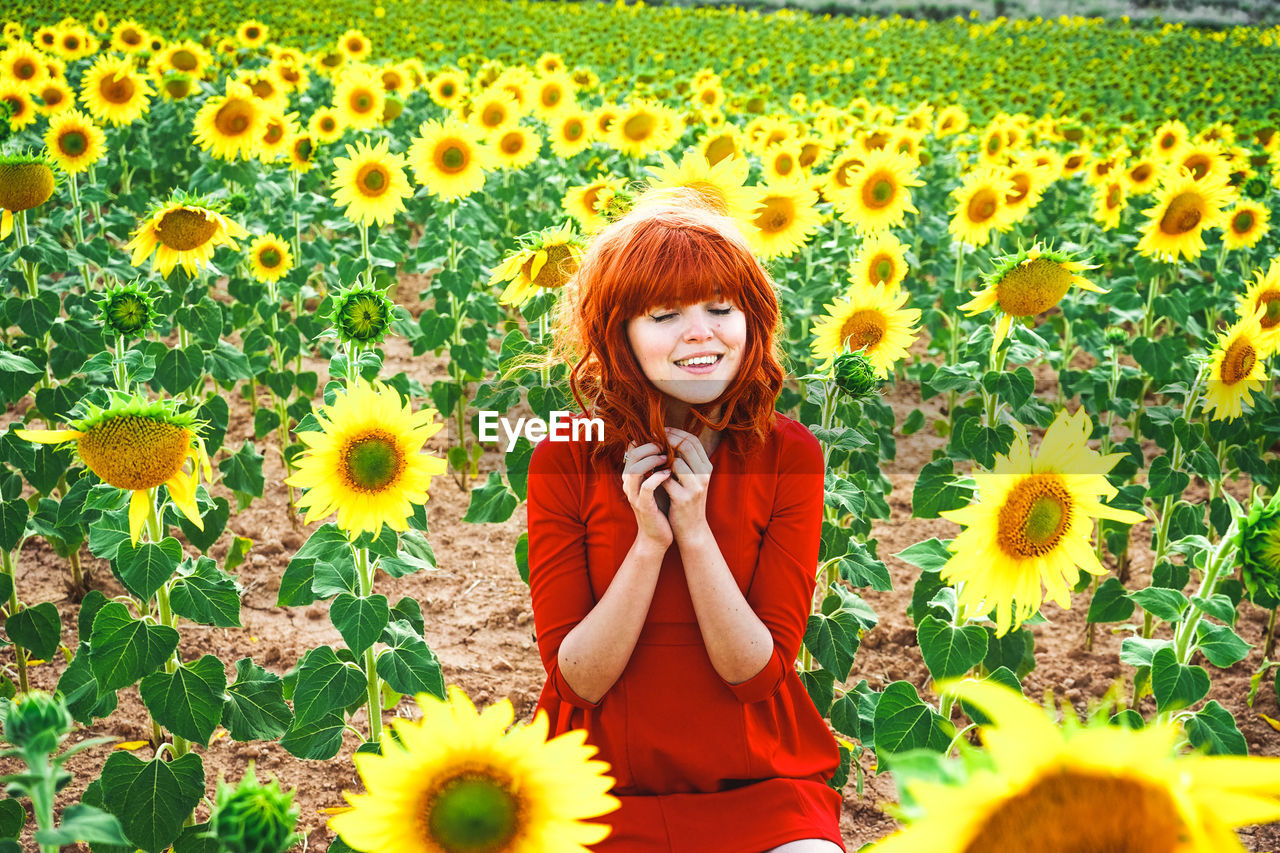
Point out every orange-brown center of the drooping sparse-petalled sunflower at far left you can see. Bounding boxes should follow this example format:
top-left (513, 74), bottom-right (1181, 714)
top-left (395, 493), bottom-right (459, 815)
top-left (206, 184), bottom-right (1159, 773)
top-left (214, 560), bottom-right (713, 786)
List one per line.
top-left (77, 415), bottom-right (191, 491)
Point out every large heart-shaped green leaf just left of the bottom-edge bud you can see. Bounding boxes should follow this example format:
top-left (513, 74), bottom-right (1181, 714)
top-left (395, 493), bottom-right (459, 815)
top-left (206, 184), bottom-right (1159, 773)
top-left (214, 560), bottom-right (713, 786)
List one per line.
top-left (101, 752), bottom-right (205, 853)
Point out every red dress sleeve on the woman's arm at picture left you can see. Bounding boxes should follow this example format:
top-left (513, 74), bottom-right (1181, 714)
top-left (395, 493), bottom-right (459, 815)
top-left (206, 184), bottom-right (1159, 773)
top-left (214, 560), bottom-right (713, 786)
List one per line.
top-left (527, 441), bottom-right (599, 708)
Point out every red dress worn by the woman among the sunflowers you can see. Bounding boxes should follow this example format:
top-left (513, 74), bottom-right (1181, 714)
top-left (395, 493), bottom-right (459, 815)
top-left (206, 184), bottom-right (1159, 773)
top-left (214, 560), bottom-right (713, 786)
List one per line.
top-left (527, 415), bottom-right (844, 853)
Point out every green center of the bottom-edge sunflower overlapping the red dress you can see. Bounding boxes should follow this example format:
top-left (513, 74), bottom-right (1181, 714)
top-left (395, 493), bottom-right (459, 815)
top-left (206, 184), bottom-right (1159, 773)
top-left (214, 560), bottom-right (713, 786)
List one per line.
top-left (426, 772), bottom-right (521, 853)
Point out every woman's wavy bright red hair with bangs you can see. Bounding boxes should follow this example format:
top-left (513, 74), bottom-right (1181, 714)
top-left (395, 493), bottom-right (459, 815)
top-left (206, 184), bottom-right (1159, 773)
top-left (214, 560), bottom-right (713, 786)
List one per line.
top-left (556, 188), bottom-right (783, 460)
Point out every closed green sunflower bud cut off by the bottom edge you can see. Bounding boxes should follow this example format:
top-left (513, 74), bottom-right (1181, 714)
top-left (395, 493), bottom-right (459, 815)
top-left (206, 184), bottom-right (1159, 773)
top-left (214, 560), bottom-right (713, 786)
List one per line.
top-left (209, 762), bottom-right (302, 853)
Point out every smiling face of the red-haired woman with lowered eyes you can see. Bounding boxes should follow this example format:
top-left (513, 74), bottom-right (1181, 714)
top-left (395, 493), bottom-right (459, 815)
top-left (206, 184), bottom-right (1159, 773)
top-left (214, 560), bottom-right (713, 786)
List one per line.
top-left (627, 297), bottom-right (746, 405)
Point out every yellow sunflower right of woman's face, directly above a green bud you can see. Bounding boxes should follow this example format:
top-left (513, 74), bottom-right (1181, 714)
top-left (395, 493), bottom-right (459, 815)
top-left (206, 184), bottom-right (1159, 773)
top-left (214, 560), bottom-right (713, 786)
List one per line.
top-left (810, 282), bottom-right (920, 379)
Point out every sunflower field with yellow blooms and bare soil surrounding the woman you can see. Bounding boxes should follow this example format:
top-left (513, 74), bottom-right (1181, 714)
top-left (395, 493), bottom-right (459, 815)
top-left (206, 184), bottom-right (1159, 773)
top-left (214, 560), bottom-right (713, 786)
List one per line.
top-left (0, 0), bottom-right (1280, 853)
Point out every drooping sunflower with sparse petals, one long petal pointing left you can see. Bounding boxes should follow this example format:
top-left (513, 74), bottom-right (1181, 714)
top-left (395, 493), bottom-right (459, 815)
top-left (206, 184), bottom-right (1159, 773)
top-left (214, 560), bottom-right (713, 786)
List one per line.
top-left (15, 391), bottom-right (212, 544)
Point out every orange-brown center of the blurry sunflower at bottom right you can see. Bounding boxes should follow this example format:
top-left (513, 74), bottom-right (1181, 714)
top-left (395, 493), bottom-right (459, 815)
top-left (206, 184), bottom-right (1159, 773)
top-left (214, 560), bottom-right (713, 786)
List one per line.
top-left (964, 771), bottom-right (1188, 853)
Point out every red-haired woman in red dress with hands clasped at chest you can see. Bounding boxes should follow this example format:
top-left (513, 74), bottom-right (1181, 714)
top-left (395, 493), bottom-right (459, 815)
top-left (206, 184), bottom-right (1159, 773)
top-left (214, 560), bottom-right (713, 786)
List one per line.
top-left (529, 191), bottom-right (844, 853)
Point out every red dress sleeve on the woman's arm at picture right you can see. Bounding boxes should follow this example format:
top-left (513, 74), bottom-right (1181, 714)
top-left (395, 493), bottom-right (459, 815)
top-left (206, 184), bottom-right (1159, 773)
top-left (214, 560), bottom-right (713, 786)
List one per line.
top-left (726, 424), bottom-right (826, 703)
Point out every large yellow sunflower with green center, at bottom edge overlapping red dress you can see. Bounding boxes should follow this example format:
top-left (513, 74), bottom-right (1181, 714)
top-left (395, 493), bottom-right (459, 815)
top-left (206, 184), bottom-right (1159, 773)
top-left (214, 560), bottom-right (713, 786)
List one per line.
top-left (329, 686), bottom-right (618, 853)
